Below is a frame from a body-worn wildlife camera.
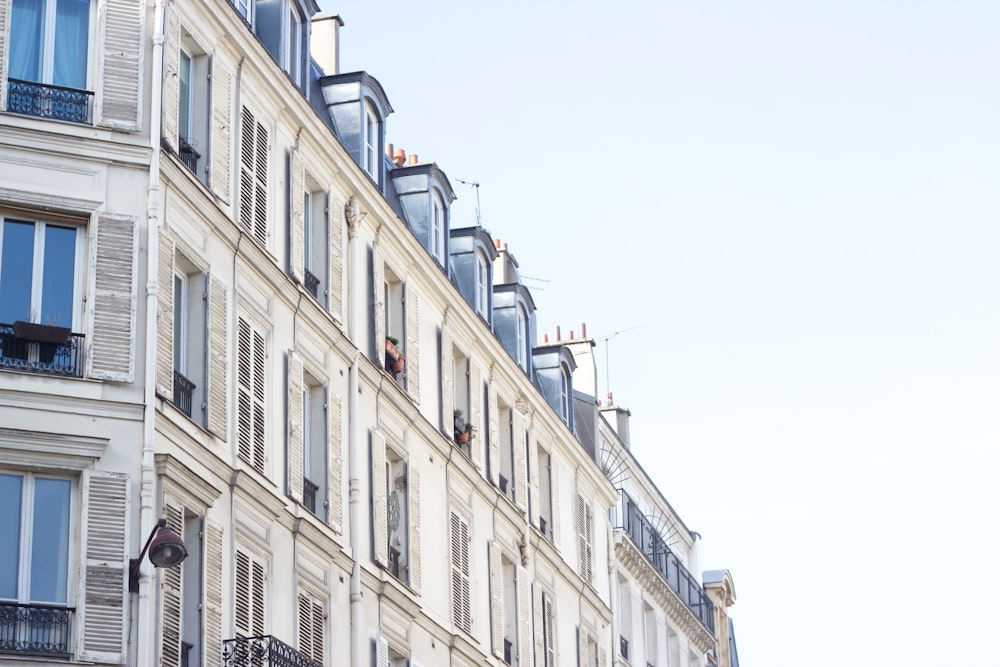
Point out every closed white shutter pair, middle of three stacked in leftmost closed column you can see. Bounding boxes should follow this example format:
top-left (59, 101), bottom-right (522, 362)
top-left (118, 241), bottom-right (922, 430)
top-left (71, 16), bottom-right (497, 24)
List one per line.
top-left (237, 317), bottom-right (265, 474)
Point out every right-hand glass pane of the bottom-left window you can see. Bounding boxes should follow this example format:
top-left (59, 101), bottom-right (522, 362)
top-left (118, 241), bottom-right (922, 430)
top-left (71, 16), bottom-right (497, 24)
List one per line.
top-left (30, 478), bottom-right (70, 602)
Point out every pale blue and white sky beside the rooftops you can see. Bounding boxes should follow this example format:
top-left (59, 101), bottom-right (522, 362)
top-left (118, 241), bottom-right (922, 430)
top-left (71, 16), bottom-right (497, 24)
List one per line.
top-left (320, 0), bottom-right (1000, 667)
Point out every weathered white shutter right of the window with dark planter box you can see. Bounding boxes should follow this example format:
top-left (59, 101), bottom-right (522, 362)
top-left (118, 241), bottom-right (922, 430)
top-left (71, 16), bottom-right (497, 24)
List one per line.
top-left (87, 213), bottom-right (136, 382)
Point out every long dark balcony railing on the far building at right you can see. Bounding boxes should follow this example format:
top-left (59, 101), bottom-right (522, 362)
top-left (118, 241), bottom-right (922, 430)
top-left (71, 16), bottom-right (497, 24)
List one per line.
top-left (615, 491), bottom-right (715, 633)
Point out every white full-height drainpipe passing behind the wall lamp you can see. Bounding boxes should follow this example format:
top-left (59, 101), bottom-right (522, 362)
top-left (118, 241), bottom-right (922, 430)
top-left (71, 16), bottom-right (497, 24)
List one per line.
top-left (136, 0), bottom-right (166, 665)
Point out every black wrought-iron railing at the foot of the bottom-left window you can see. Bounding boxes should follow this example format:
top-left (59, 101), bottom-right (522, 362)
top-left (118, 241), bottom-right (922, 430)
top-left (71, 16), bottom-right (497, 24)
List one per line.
top-left (0, 602), bottom-right (76, 657)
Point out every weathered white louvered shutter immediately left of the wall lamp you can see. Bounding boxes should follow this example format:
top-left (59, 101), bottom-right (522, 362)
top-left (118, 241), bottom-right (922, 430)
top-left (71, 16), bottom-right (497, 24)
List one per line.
top-left (77, 470), bottom-right (130, 664)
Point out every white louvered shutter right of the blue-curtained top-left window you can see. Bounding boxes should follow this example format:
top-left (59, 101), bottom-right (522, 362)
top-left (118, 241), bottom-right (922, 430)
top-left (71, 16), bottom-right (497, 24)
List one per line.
top-left (96, 0), bottom-right (146, 131)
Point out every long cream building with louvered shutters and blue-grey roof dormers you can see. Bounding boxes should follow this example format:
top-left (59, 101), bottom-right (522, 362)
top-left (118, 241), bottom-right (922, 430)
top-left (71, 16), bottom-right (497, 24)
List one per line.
top-left (0, 0), bottom-right (736, 667)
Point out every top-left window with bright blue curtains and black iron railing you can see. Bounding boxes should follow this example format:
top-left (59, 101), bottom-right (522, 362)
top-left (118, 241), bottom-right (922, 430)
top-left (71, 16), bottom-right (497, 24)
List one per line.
top-left (7, 0), bottom-right (93, 123)
